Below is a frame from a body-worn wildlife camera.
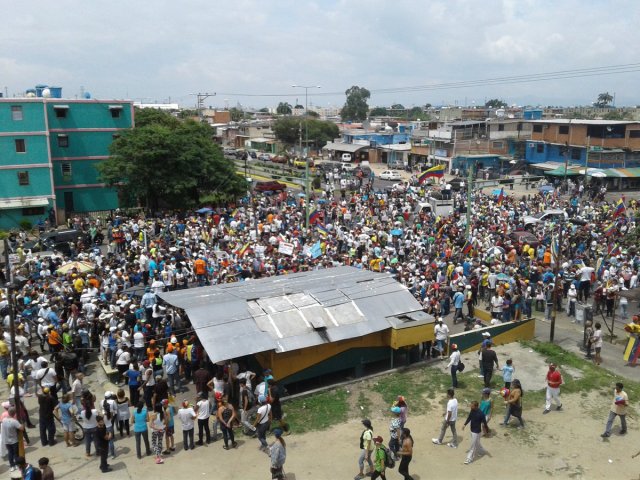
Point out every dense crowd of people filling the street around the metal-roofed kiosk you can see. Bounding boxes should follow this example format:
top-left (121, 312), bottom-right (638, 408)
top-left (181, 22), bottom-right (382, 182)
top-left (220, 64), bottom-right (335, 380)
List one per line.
top-left (0, 170), bottom-right (640, 478)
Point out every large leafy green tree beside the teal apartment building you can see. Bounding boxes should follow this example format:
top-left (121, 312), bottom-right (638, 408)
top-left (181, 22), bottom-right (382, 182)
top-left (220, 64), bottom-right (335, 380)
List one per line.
top-left (98, 112), bottom-right (246, 209)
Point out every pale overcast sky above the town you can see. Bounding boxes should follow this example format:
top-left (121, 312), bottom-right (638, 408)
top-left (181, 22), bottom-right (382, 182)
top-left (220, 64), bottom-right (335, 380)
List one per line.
top-left (5, 0), bottom-right (640, 108)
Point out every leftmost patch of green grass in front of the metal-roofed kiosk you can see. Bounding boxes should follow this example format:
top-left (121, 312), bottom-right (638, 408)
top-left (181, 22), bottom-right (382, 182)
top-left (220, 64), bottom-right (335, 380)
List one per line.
top-left (285, 387), bottom-right (349, 433)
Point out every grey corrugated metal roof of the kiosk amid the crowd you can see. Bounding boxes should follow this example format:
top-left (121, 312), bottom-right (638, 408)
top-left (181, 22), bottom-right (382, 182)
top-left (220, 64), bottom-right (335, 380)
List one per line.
top-left (159, 267), bottom-right (433, 362)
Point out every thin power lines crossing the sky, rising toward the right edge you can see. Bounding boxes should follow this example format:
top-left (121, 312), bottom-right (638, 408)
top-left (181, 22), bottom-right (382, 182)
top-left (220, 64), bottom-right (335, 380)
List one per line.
top-left (212, 63), bottom-right (640, 97)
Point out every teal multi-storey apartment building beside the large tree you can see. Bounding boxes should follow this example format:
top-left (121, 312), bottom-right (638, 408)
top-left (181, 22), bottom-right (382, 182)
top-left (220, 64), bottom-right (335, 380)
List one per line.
top-left (0, 89), bottom-right (134, 230)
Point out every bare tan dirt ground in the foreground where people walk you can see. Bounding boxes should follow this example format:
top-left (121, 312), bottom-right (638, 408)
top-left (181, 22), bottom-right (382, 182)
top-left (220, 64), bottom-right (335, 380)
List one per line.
top-left (10, 344), bottom-right (640, 480)
